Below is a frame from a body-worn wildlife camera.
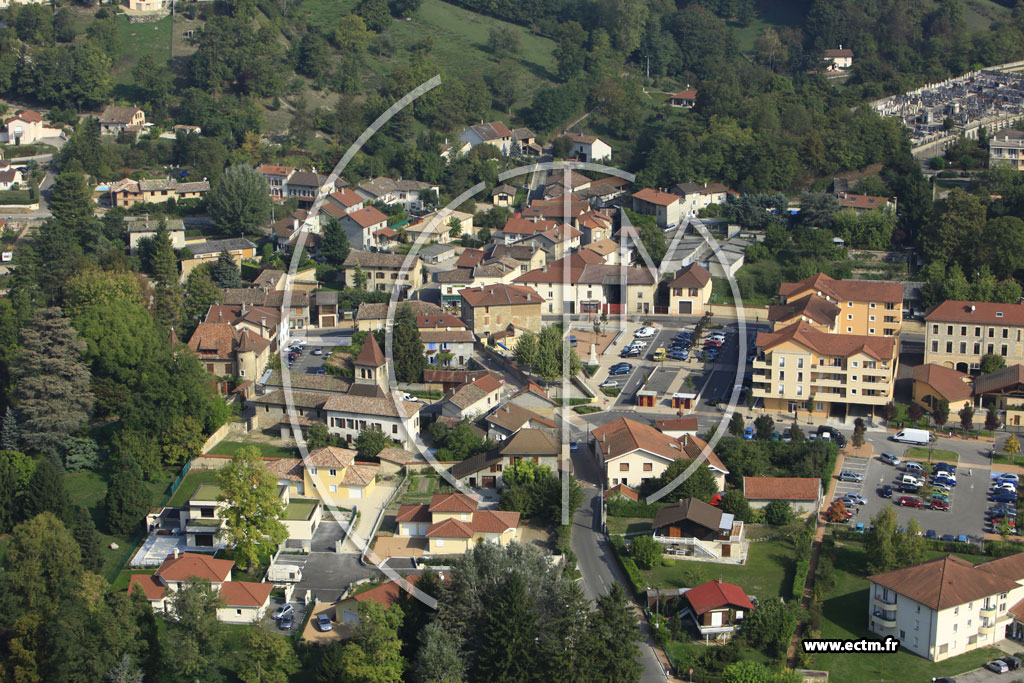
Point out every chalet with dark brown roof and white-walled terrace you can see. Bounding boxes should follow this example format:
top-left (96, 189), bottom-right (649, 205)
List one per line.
top-left (650, 498), bottom-right (746, 561)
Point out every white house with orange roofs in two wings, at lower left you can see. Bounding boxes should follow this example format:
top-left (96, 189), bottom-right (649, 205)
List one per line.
top-left (128, 550), bottom-right (273, 624)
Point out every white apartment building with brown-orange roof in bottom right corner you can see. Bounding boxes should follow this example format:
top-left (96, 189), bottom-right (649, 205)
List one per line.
top-left (865, 553), bottom-right (1024, 661)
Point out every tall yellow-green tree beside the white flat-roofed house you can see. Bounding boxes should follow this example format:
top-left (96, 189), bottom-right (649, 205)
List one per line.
top-left (217, 446), bottom-right (288, 569)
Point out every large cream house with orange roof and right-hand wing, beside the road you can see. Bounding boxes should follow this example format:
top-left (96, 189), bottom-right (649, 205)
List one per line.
top-left (591, 418), bottom-right (729, 490)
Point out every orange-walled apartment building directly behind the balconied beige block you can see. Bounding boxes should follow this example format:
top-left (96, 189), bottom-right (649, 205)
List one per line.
top-left (768, 273), bottom-right (903, 337)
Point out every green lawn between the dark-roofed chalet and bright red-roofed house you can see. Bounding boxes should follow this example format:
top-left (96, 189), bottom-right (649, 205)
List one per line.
top-left (638, 540), bottom-right (796, 598)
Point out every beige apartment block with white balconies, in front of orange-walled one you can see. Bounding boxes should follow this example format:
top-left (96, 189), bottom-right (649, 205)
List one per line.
top-left (754, 322), bottom-right (899, 416)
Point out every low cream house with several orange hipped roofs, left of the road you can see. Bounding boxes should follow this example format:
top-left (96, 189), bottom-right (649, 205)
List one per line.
top-left (395, 494), bottom-right (519, 555)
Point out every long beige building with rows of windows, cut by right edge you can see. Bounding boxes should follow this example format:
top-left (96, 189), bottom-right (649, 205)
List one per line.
top-left (925, 301), bottom-right (1024, 373)
